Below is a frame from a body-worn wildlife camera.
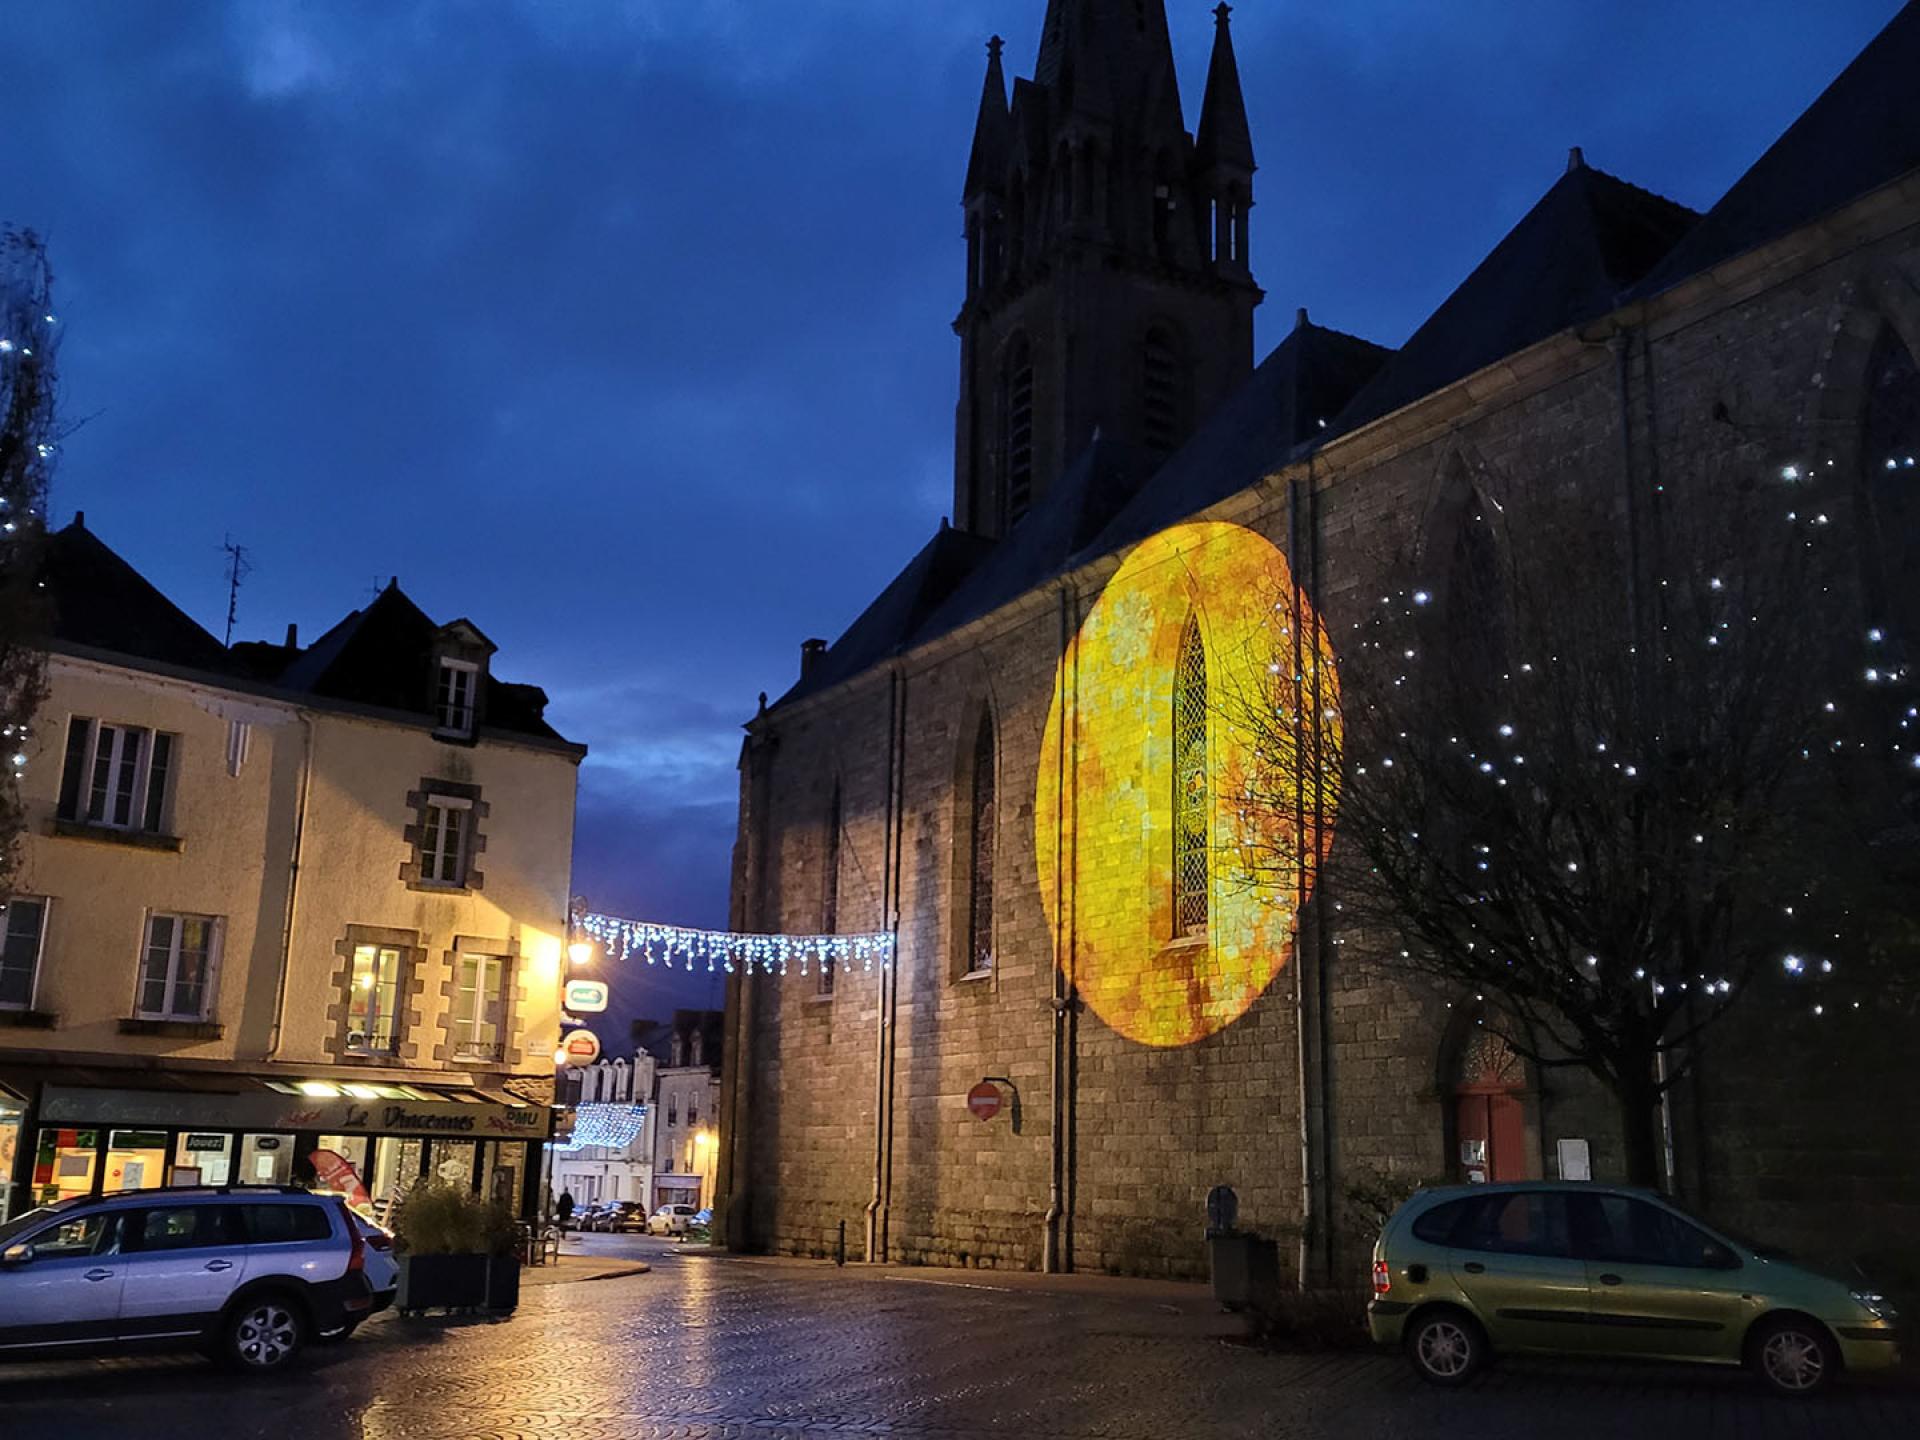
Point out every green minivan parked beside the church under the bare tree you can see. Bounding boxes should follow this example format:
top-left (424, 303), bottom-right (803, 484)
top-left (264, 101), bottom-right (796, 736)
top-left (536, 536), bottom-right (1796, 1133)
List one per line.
top-left (1367, 1183), bottom-right (1899, 1396)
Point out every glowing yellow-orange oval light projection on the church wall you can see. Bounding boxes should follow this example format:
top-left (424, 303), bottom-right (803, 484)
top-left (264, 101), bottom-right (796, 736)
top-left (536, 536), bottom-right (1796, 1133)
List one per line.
top-left (1033, 522), bottom-right (1340, 1046)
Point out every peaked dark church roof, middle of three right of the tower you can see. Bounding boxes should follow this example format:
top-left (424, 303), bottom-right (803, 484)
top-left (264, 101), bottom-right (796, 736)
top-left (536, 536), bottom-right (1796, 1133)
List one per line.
top-left (1329, 152), bottom-right (1699, 434)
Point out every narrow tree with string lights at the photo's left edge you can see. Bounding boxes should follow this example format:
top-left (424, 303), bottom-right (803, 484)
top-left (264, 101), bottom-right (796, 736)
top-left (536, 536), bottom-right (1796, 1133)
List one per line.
top-left (0, 228), bottom-right (58, 902)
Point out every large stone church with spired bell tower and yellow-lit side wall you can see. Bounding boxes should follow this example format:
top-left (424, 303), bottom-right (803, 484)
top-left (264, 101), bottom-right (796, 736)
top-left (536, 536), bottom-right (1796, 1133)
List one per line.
top-left (718, 2), bottom-right (1920, 1279)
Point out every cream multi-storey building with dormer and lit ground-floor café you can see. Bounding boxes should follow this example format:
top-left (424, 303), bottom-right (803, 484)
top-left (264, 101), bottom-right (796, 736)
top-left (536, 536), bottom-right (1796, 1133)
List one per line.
top-left (0, 516), bottom-right (584, 1210)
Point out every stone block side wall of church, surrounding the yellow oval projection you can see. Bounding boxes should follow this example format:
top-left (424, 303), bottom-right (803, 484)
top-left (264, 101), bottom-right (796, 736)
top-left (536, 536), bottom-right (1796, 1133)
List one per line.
top-left (725, 183), bottom-right (1920, 1281)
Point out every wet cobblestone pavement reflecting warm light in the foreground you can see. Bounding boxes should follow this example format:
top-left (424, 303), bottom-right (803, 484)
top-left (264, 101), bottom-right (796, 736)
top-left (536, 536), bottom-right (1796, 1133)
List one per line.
top-left (0, 1246), bottom-right (1920, 1440)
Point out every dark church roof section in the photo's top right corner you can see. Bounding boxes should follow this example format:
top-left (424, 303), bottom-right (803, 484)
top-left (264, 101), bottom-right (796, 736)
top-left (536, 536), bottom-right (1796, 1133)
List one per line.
top-left (1638, 4), bottom-right (1920, 294)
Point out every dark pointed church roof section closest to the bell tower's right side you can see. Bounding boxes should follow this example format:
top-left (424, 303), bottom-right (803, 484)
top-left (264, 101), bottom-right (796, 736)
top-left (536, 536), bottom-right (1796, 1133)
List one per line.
top-left (1075, 311), bottom-right (1394, 563)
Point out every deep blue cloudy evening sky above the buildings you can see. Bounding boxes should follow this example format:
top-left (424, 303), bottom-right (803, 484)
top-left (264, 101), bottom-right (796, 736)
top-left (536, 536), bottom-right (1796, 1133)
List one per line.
top-left (0, 0), bottom-right (1899, 1012)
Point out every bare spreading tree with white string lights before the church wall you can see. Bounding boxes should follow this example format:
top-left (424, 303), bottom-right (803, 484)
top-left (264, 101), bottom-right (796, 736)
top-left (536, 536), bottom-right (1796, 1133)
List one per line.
top-left (1217, 440), bottom-right (1912, 1185)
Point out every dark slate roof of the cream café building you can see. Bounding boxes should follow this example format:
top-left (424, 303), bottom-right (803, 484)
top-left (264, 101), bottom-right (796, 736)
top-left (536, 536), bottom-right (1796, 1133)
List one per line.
top-left (44, 516), bottom-right (561, 741)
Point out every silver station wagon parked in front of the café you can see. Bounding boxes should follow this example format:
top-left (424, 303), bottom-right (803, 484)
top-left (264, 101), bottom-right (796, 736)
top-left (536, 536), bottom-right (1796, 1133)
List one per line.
top-left (0, 1187), bottom-right (374, 1371)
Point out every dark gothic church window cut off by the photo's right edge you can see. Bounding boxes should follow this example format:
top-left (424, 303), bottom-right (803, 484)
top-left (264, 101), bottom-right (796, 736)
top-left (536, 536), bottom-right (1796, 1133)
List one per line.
top-left (1860, 328), bottom-right (1920, 655)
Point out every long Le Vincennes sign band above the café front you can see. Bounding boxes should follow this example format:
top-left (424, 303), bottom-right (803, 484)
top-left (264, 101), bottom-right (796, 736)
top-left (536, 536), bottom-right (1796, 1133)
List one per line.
top-left (40, 1085), bottom-right (549, 1140)
